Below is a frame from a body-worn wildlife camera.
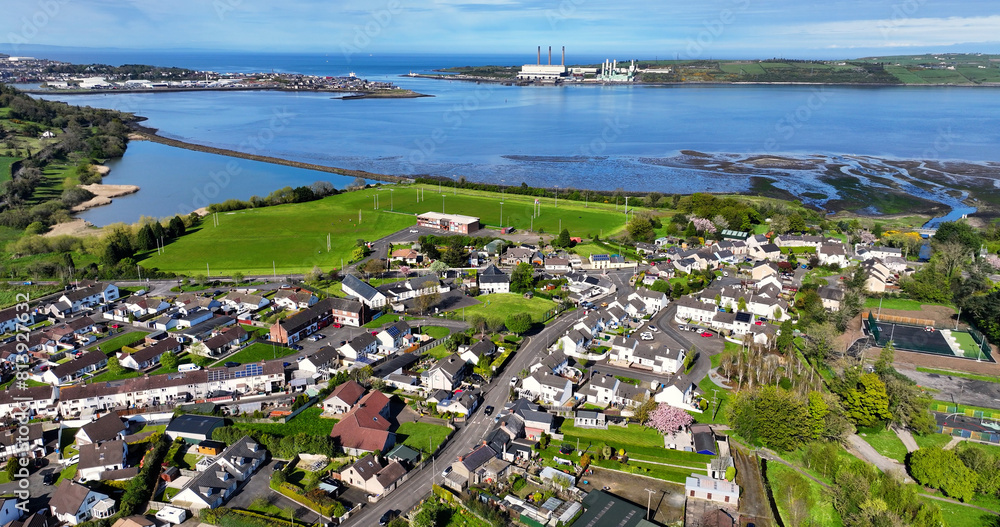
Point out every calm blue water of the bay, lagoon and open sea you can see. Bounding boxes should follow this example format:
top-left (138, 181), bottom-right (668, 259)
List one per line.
top-left (29, 53), bottom-right (1000, 223)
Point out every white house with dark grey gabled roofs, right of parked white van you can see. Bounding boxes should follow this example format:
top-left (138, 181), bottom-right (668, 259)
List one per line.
top-left (171, 436), bottom-right (267, 511)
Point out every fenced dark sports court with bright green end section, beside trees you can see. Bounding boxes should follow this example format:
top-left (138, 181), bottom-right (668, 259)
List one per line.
top-left (865, 312), bottom-right (993, 362)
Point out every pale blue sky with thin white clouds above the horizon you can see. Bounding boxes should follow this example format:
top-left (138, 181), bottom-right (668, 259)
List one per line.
top-left (0, 0), bottom-right (1000, 60)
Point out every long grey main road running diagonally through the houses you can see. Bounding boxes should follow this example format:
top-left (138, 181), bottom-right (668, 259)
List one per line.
top-left (344, 312), bottom-right (580, 527)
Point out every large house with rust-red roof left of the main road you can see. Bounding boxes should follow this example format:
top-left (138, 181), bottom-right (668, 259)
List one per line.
top-left (330, 391), bottom-right (396, 456)
